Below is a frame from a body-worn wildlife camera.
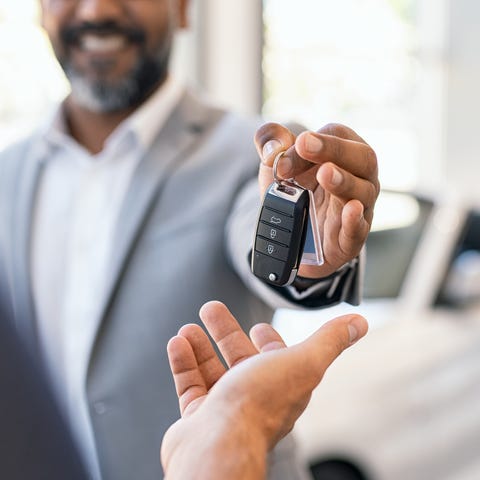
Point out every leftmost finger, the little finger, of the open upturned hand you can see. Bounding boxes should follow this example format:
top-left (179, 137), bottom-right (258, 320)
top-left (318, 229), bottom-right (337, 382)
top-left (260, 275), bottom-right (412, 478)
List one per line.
top-left (167, 336), bottom-right (207, 416)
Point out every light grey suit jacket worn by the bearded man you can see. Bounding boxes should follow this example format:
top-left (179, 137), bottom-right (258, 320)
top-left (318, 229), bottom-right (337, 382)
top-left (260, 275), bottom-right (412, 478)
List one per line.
top-left (0, 94), bottom-right (358, 480)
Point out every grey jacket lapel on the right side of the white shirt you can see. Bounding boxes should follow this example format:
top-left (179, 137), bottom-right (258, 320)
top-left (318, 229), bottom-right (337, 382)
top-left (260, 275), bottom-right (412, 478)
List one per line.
top-left (97, 94), bottom-right (211, 334)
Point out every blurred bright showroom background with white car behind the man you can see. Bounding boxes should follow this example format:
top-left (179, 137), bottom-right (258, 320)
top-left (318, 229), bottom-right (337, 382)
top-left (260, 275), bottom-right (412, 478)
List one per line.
top-left (0, 0), bottom-right (480, 480)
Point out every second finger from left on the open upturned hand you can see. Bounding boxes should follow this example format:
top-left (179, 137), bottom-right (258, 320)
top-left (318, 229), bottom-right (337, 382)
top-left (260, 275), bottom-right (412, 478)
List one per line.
top-left (178, 324), bottom-right (225, 390)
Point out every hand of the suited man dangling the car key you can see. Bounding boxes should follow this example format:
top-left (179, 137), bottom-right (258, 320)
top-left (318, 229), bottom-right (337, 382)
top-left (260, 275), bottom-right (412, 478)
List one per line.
top-left (255, 123), bottom-right (380, 278)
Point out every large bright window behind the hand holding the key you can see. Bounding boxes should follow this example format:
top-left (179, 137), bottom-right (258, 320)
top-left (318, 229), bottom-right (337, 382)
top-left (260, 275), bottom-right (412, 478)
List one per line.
top-left (263, 0), bottom-right (440, 189)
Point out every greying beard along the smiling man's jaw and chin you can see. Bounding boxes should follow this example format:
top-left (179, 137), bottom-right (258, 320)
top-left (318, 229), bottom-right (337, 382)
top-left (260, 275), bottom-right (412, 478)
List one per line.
top-left (62, 55), bottom-right (169, 113)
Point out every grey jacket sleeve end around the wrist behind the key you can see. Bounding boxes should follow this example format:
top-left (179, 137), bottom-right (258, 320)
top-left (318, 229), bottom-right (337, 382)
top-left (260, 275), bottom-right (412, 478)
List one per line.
top-left (225, 179), bottom-right (365, 309)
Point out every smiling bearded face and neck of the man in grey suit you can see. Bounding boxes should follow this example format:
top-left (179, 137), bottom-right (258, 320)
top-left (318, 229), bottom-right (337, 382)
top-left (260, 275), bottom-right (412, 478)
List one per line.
top-left (42, 0), bottom-right (188, 153)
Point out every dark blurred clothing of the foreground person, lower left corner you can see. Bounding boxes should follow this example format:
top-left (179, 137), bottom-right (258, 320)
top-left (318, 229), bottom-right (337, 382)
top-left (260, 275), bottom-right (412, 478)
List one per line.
top-left (0, 284), bottom-right (87, 480)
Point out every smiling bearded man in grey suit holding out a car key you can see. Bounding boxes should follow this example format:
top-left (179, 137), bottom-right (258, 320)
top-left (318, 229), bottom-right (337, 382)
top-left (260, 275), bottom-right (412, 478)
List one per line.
top-left (0, 0), bottom-right (379, 480)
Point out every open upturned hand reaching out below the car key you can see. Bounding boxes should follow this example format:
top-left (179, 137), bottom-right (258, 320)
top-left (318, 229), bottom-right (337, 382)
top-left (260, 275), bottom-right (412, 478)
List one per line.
top-left (161, 302), bottom-right (368, 480)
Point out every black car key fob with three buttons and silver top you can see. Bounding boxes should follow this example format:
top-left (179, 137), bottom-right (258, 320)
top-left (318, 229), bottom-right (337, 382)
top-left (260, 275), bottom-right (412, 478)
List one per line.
top-left (251, 182), bottom-right (310, 286)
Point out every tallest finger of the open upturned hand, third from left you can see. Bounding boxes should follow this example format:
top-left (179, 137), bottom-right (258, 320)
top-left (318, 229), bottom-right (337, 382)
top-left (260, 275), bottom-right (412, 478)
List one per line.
top-left (200, 301), bottom-right (258, 367)
